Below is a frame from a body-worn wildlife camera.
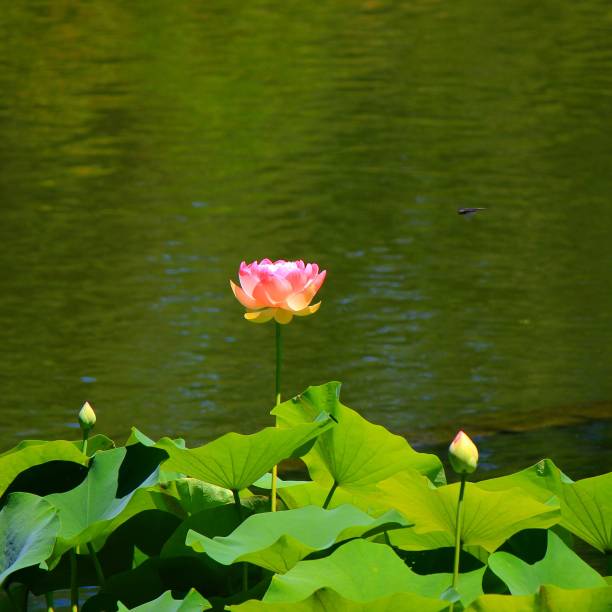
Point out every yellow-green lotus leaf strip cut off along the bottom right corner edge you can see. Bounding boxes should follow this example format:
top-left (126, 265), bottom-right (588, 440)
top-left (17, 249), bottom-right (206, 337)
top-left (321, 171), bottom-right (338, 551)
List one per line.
top-left (466, 585), bottom-right (612, 612)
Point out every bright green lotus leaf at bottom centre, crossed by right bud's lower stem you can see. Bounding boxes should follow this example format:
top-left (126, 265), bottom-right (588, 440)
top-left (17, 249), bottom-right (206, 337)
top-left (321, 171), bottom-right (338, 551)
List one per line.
top-left (263, 539), bottom-right (486, 605)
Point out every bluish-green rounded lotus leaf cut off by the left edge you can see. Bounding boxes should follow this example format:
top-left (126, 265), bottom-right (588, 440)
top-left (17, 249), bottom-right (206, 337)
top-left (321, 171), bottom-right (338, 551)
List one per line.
top-left (0, 493), bottom-right (60, 584)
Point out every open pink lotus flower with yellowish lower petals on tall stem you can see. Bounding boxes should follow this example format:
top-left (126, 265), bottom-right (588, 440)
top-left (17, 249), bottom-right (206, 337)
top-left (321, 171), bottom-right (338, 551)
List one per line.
top-left (230, 259), bottom-right (326, 324)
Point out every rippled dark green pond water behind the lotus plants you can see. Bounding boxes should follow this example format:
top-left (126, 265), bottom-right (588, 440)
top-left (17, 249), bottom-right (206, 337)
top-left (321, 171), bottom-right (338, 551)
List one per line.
top-left (0, 0), bottom-right (612, 477)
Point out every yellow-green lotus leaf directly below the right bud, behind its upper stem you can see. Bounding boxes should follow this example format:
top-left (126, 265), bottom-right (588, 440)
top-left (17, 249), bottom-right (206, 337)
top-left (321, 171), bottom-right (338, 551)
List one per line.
top-left (378, 473), bottom-right (560, 552)
